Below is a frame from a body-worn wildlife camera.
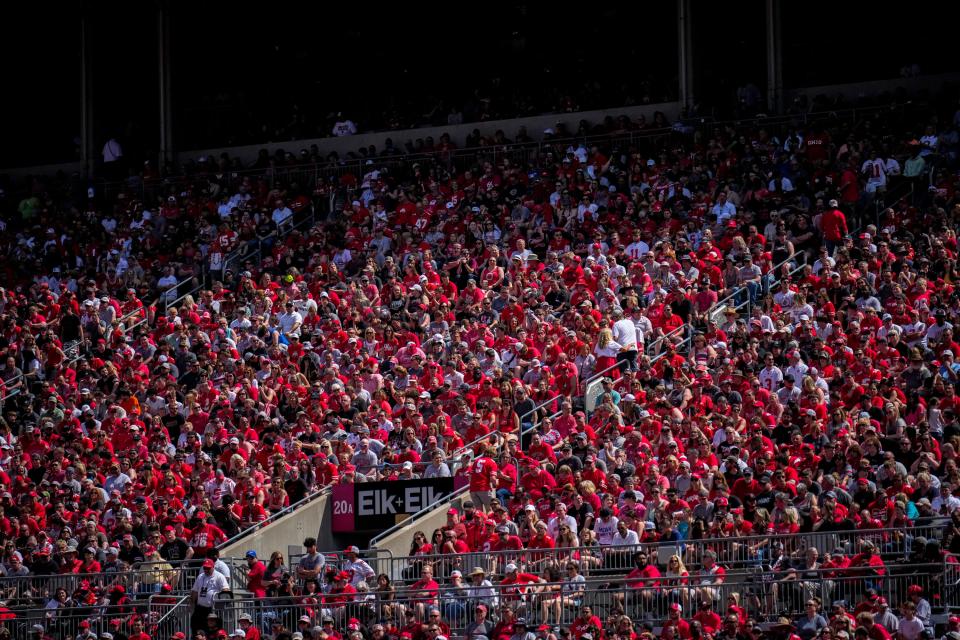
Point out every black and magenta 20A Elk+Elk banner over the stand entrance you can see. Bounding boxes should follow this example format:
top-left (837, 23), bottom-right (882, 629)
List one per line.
top-left (331, 478), bottom-right (465, 533)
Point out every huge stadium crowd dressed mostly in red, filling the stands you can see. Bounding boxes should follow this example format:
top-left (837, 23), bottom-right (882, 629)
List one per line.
top-left (0, 92), bottom-right (960, 640)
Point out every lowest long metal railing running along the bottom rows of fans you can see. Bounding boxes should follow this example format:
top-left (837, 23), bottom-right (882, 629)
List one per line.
top-left (197, 563), bottom-right (956, 635)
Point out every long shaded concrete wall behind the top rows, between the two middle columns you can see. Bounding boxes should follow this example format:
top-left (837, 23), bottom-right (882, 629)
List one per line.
top-left (178, 102), bottom-right (680, 162)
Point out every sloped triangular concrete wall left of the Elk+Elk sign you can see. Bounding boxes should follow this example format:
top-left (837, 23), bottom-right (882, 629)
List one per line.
top-left (220, 493), bottom-right (336, 559)
